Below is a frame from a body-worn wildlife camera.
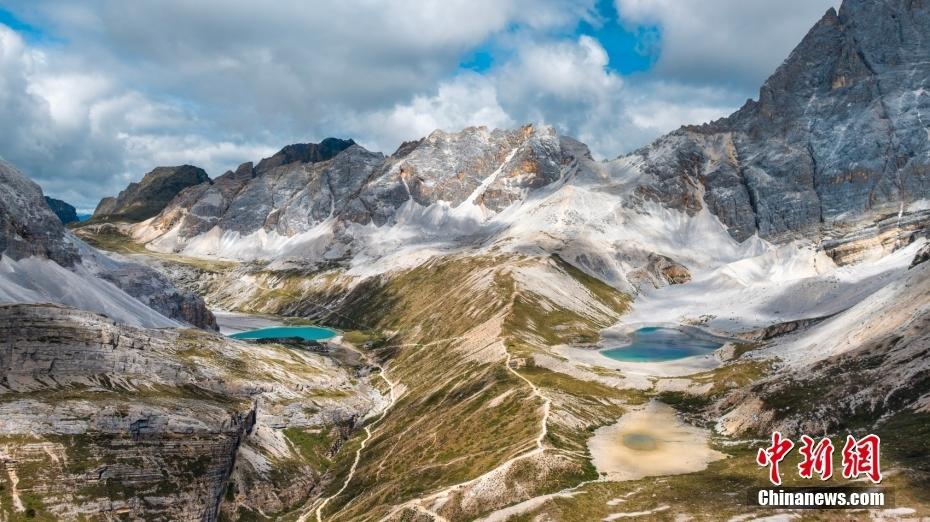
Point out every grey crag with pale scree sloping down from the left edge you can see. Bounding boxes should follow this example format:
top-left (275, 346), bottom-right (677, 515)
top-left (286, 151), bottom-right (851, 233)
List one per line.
top-left (0, 161), bottom-right (216, 329)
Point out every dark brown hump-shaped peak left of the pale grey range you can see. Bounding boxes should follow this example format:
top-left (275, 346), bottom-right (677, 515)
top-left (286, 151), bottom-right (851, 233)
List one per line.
top-left (92, 165), bottom-right (210, 222)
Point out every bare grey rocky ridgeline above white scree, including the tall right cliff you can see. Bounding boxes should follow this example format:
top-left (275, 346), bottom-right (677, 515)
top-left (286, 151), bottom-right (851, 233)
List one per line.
top-left (98, 0), bottom-right (930, 268)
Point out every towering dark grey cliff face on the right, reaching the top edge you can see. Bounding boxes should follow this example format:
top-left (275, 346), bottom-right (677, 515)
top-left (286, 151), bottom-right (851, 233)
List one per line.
top-left (636, 0), bottom-right (930, 240)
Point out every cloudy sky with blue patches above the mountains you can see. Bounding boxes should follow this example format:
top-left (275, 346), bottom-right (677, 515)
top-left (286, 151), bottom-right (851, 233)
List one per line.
top-left (0, 0), bottom-right (837, 211)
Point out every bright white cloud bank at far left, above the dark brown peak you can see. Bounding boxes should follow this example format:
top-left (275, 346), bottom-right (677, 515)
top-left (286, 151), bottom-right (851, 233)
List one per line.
top-left (0, 25), bottom-right (275, 210)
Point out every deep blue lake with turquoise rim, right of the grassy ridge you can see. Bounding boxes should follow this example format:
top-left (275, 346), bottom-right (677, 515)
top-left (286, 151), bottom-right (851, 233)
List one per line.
top-left (601, 326), bottom-right (723, 362)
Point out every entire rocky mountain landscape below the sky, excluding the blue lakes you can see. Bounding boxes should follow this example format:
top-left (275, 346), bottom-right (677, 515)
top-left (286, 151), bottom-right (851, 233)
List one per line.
top-left (0, 0), bottom-right (930, 520)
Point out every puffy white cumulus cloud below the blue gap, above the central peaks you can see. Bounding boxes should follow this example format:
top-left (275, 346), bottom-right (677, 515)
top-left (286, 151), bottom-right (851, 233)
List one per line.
top-left (362, 36), bottom-right (735, 158)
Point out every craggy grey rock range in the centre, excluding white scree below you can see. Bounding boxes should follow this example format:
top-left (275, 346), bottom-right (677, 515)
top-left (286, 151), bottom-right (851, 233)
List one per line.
top-left (140, 125), bottom-right (588, 248)
